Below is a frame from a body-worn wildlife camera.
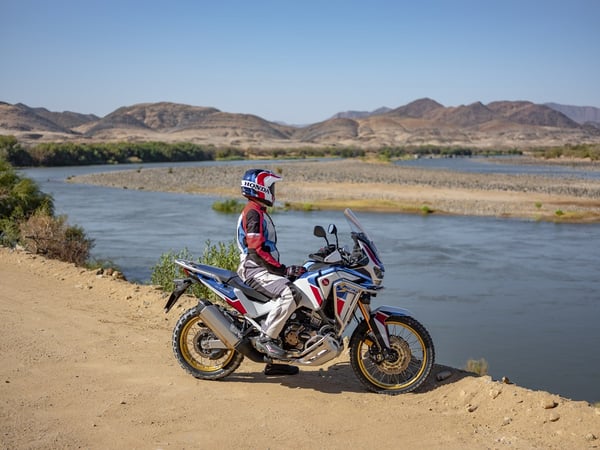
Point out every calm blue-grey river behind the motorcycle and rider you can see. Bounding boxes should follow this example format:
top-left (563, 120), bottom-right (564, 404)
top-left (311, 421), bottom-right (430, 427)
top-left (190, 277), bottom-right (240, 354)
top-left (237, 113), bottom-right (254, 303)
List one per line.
top-left (23, 162), bottom-right (600, 402)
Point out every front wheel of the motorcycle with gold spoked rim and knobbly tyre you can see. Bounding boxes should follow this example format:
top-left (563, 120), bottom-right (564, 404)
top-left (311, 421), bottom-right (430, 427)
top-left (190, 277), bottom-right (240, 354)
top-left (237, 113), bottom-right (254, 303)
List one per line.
top-left (350, 316), bottom-right (435, 395)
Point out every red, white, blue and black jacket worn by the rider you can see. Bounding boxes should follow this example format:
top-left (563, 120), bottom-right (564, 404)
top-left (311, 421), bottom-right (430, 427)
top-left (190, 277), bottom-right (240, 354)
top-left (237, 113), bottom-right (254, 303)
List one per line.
top-left (237, 200), bottom-right (285, 275)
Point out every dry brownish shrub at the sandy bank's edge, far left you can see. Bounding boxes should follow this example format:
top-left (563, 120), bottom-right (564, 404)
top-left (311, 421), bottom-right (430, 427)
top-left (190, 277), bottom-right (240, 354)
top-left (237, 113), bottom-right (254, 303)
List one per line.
top-left (19, 211), bottom-right (94, 266)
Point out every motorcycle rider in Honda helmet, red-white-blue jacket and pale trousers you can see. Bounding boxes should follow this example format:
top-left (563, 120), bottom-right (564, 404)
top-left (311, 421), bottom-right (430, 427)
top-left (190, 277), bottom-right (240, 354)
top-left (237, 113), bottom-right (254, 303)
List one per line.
top-left (237, 169), bottom-right (304, 375)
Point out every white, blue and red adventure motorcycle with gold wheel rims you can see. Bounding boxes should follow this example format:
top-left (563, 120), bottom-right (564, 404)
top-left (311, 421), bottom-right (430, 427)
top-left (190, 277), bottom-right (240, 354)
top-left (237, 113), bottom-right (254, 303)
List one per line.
top-left (164, 209), bottom-right (435, 395)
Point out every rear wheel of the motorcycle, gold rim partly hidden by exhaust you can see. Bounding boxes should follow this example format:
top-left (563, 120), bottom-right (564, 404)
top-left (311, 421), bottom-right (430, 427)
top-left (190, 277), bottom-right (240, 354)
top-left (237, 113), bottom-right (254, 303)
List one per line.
top-left (173, 306), bottom-right (244, 380)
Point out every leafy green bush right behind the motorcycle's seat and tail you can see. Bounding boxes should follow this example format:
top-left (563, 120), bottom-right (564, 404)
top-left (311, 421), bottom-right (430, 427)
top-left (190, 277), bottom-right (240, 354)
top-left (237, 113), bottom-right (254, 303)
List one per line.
top-left (150, 240), bottom-right (240, 300)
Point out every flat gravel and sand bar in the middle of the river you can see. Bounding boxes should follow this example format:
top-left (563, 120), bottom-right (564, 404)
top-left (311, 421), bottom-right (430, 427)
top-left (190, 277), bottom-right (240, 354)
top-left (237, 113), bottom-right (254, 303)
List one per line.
top-left (70, 160), bottom-right (600, 222)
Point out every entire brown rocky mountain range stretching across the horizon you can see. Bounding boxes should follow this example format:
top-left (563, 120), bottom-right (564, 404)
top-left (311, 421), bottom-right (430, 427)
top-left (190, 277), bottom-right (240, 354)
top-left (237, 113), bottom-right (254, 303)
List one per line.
top-left (0, 98), bottom-right (600, 148)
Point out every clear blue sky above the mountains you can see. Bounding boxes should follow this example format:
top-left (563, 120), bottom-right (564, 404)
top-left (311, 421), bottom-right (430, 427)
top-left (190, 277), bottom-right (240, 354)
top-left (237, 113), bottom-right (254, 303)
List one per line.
top-left (0, 0), bottom-right (600, 124)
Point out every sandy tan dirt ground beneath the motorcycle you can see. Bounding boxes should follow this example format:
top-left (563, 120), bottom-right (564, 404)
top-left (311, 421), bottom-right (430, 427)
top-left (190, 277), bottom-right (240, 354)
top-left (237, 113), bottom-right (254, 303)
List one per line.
top-left (0, 247), bottom-right (600, 449)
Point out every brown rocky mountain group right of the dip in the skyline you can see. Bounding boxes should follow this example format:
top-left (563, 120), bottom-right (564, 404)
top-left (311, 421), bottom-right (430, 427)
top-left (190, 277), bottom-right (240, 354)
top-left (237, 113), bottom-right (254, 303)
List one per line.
top-left (304, 98), bottom-right (600, 148)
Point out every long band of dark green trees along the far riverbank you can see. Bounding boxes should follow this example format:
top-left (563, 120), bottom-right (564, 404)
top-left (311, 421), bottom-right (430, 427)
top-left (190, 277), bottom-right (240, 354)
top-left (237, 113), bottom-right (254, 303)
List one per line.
top-left (0, 135), bottom-right (600, 167)
